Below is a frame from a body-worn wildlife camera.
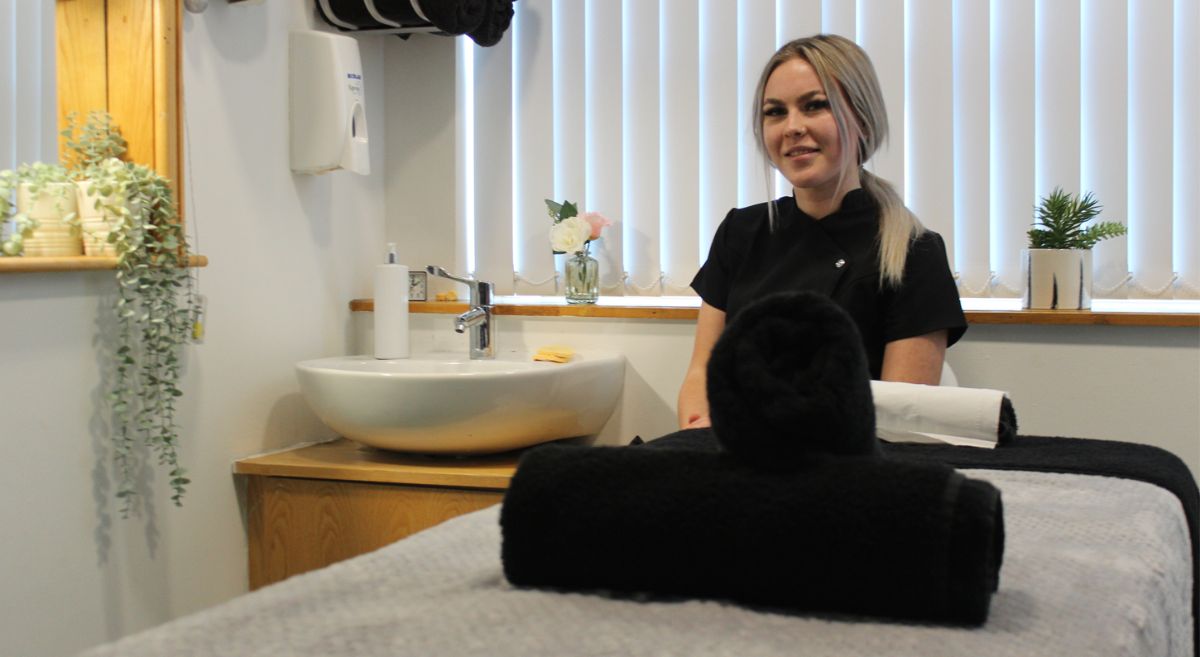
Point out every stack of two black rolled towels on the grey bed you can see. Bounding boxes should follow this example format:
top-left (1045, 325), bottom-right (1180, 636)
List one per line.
top-left (500, 293), bottom-right (1003, 625)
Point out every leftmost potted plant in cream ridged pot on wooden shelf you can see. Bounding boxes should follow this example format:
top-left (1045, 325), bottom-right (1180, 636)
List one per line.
top-left (0, 162), bottom-right (83, 257)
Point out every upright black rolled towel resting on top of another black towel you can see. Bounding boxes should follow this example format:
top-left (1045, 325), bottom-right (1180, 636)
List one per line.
top-left (707, 291), bottom-right (880, 470)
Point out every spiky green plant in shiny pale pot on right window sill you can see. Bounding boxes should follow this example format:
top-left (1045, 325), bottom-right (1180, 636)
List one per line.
top-left (1021, 187), bottom-right (1126, 309)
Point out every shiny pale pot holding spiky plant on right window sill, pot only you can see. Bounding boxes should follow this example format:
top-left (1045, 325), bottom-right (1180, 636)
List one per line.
top-left (1021, 248), bottom-right (1092, 311)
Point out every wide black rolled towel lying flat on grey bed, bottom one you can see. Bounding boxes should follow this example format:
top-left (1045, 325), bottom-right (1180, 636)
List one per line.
top-left (500, 445), bottom-right (1003, 625)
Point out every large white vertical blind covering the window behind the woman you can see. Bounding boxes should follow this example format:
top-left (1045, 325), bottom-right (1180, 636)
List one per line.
top-left (457, 0), bottom-right (1200, 299)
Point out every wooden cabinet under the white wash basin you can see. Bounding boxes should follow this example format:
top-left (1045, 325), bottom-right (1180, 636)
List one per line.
top-left (234, 439), bottom-right (517, 589)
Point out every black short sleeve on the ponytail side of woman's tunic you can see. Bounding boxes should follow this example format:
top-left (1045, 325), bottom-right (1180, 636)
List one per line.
top-left (883, 230), bottom-right (967, 346)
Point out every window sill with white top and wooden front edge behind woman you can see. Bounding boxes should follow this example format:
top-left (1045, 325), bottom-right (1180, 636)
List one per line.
top-left (350, 296), bottom-right (1200, 327)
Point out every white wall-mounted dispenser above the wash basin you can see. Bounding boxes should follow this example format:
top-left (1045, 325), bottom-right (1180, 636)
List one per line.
top-left (289, 30), bottom-right (371, 175)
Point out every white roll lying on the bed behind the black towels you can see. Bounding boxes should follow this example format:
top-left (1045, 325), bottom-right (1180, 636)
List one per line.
top-left (871, 381), bottom-right (1016, 447)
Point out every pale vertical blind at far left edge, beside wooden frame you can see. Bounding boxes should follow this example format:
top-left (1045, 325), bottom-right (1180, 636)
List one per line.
top-left (0, 0), bottom-right (58, 169)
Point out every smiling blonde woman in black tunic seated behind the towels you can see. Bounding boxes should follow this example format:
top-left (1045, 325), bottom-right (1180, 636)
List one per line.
top-left (678, 35), bottom-right (966, 428)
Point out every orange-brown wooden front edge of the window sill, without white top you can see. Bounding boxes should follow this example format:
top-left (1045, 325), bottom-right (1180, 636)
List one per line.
top-left (350, 299), bottom-right (1200, 327)
